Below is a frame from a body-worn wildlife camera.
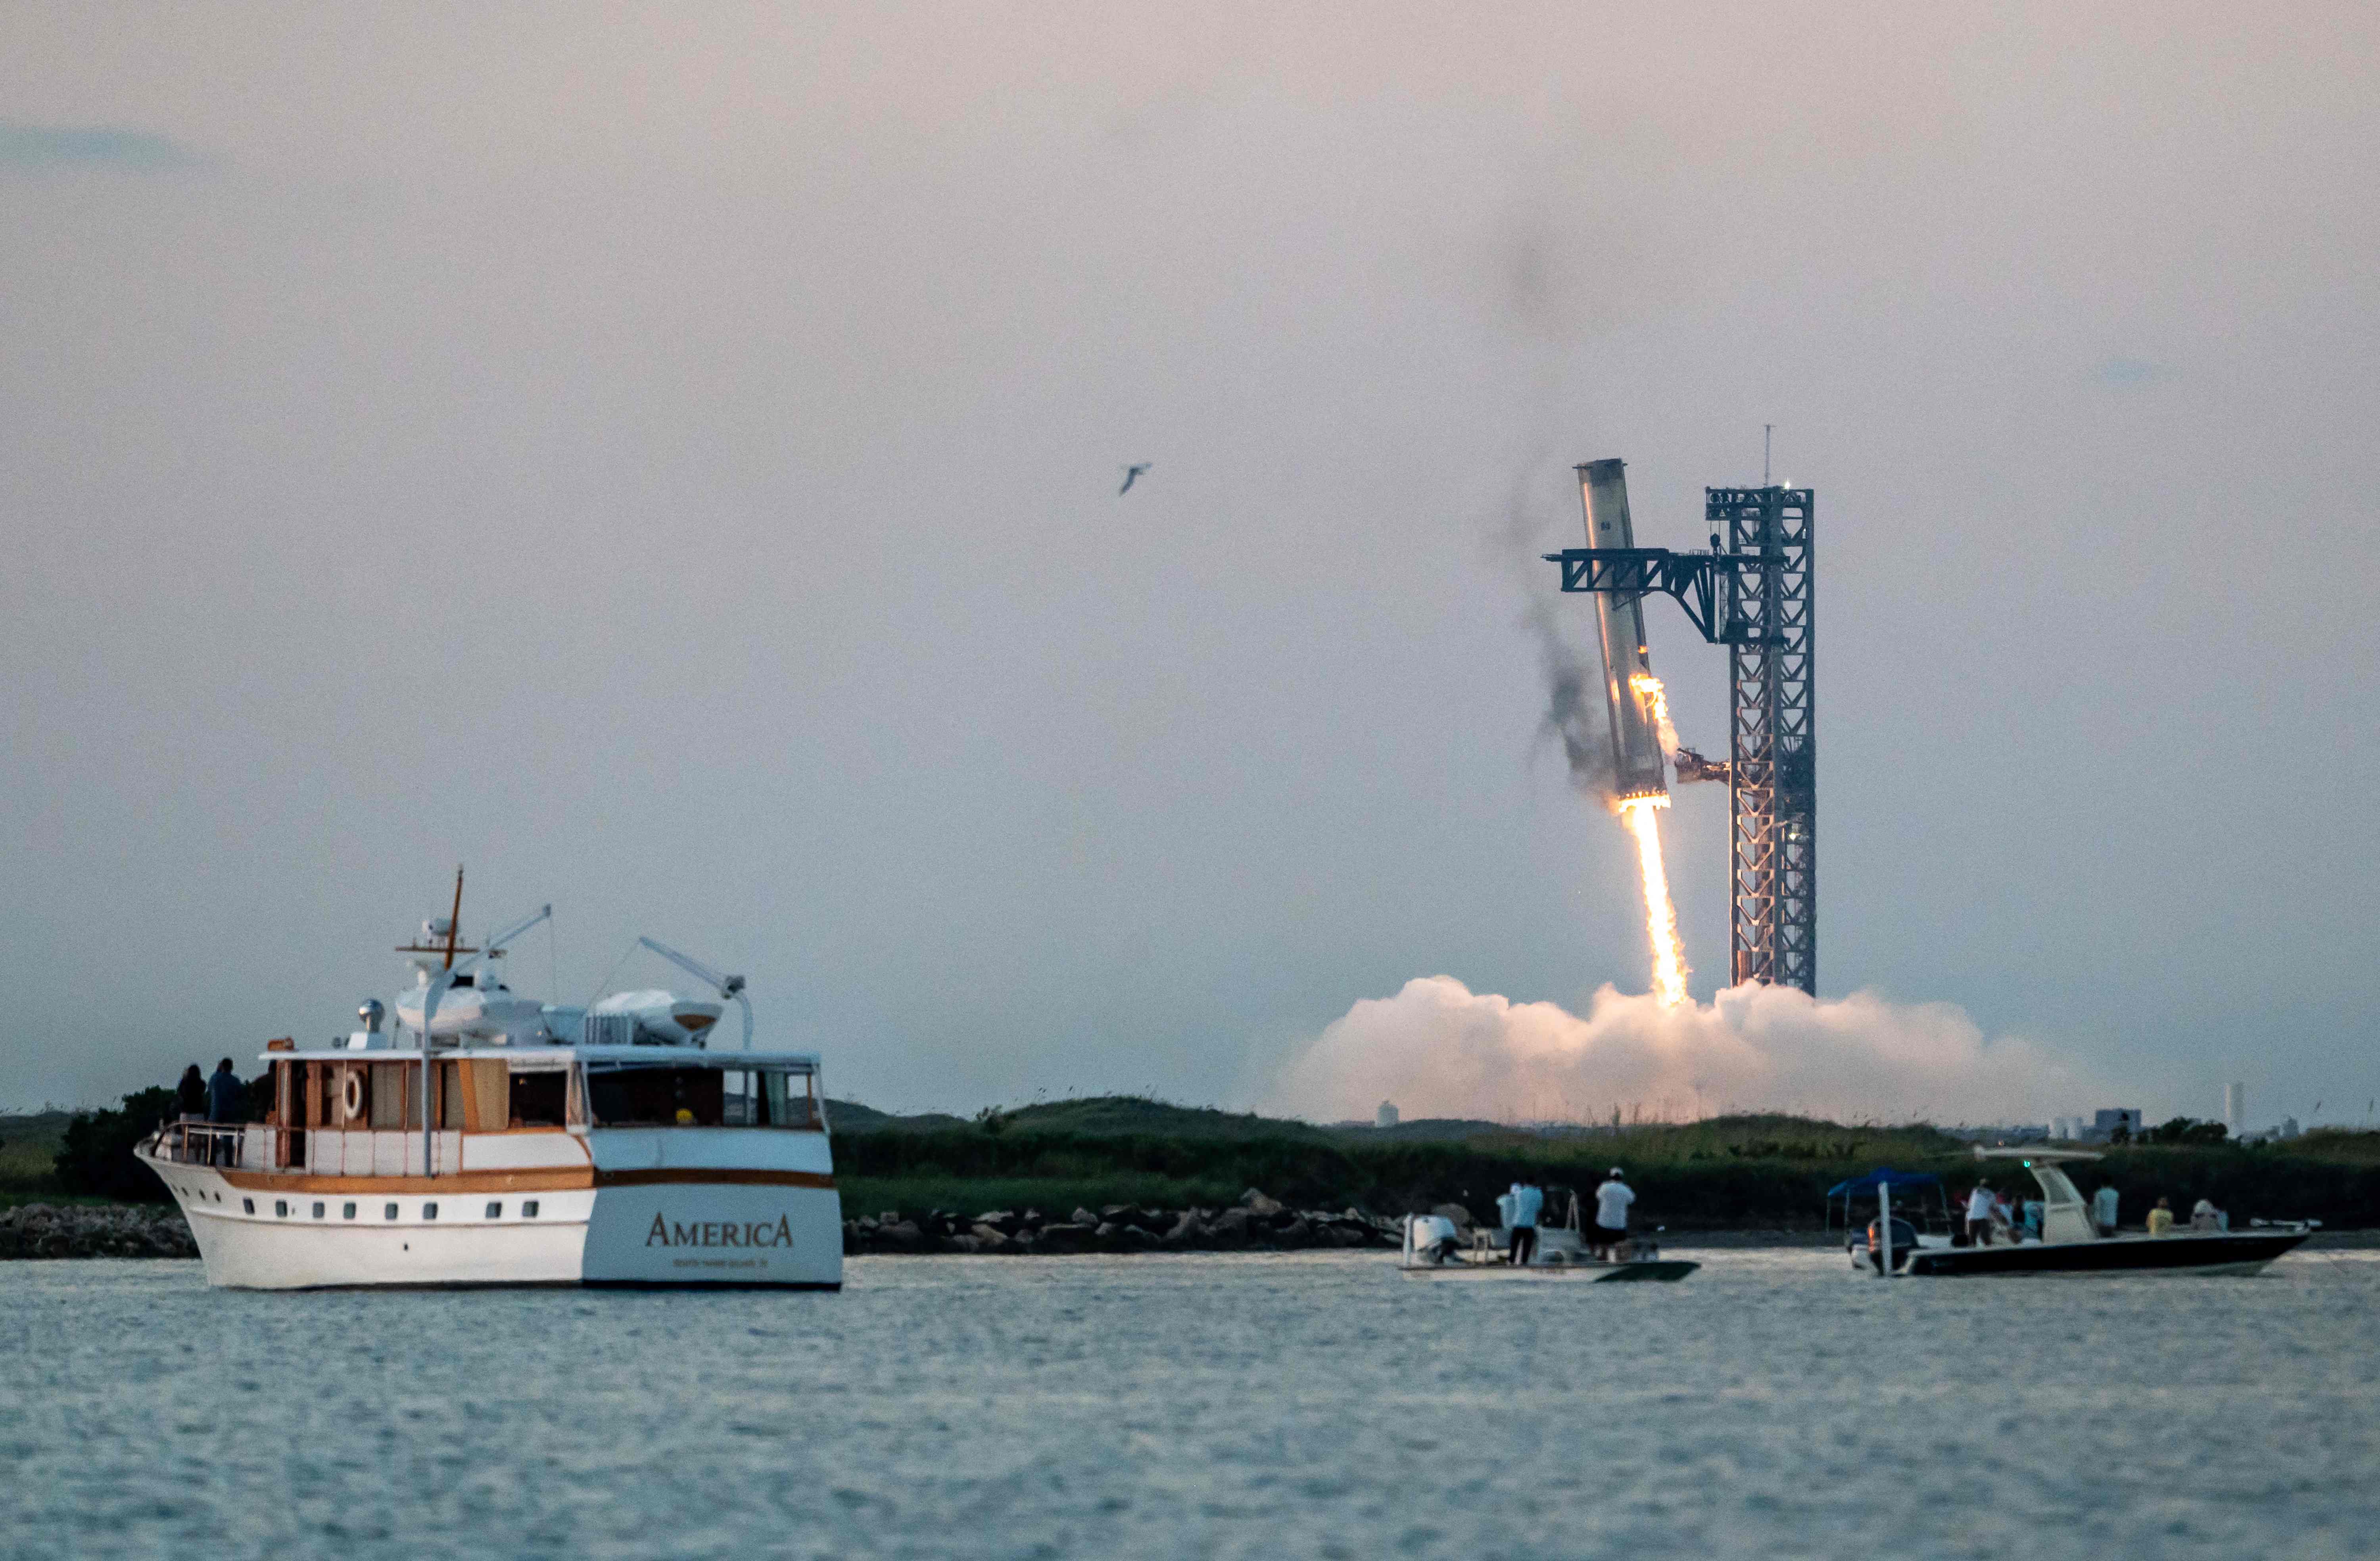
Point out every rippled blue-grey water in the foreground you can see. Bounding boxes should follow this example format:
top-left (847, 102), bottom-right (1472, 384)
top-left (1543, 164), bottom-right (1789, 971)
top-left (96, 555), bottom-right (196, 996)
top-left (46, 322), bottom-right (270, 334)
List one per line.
top-left (0, 1252), bottom-right (2380, 1561)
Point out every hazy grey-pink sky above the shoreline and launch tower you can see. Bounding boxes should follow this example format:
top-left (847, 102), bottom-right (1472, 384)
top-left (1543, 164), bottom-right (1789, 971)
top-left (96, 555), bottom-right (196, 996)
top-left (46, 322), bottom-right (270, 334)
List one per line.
top-left (0, 2), bottom-right (2380, 1123)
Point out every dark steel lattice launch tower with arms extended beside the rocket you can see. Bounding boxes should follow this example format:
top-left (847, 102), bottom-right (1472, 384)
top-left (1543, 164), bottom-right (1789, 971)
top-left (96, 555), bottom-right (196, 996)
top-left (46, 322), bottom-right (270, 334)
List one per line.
top-left (1545, 473), bottom-right (1818, 997)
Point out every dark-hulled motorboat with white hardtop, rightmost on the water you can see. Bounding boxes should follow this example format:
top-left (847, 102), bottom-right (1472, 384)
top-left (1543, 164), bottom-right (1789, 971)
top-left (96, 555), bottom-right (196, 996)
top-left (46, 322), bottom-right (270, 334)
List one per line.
top-left (1864, 1147), bottom-right (2316, 1278)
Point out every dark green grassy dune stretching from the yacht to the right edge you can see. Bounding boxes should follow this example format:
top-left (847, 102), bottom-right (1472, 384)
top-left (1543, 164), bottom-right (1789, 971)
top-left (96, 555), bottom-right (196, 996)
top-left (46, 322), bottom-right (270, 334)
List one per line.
top-left (835, 1097), bottom-right (2380, 1230)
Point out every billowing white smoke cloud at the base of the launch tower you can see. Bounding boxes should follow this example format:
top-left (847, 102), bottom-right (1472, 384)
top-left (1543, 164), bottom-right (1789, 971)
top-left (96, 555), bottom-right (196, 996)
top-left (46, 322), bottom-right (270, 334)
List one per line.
top-left (1264, 975), bottom-right (2102, 1123)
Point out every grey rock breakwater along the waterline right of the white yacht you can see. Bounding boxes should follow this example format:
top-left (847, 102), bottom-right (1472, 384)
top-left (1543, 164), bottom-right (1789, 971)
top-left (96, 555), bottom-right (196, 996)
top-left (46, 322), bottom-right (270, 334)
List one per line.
top-left (843, 1187), bottom-right (1402, 1256)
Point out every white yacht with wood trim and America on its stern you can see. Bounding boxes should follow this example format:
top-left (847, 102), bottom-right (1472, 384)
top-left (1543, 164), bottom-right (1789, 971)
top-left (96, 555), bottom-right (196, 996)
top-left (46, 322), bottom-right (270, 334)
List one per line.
top-left (136, 873), bottom-right (843, 1290)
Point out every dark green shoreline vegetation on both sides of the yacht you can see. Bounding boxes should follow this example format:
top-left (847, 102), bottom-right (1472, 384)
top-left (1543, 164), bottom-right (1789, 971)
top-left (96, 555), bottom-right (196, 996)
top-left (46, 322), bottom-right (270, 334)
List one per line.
top-left (0, 1090), bottom-right (2380, 1252)
